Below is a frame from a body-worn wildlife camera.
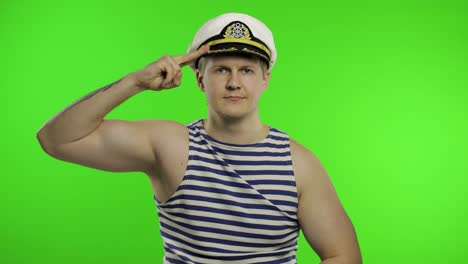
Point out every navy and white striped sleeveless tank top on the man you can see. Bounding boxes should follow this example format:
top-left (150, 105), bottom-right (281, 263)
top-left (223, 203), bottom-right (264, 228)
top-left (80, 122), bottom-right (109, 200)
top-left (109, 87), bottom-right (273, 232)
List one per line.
top-left (156, 120), bottom-right (299, 264)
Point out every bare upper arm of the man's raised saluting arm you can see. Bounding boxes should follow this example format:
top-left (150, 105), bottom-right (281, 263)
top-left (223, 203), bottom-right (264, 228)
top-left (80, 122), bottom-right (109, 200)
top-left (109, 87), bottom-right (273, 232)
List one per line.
top-left (52, 120), bottom-right (154, 172)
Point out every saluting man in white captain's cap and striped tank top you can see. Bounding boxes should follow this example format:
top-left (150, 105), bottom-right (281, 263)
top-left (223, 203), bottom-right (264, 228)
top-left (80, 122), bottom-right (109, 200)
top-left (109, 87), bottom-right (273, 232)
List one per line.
top-left (37, 13), bottom-right (361, 263)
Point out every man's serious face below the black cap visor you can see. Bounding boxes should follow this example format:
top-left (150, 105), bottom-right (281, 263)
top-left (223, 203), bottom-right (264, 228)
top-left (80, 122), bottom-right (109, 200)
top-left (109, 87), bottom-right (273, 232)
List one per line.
top-left (197, 56), bottom-right (270, 119)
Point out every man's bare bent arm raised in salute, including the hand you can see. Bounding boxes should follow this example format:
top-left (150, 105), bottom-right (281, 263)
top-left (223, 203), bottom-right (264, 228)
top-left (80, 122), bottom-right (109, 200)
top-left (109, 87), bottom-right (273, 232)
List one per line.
top-left (37, 47), bottom-right (208, 172)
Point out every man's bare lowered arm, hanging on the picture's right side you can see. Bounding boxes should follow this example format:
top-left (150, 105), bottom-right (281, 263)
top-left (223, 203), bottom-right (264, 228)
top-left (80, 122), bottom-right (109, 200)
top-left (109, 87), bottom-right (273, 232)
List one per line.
top-left (291, 140), bottom-right (362, 264)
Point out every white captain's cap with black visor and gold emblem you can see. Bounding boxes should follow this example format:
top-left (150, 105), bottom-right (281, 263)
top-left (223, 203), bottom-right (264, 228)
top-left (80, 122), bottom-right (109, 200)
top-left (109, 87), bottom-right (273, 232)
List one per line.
top-left (188, 13), bottom-right (276, 71)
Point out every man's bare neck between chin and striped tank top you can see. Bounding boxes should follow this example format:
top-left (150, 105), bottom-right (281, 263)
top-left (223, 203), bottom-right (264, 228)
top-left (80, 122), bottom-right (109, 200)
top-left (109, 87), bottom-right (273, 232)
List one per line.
top-left (203, 111), bottom-right (270, 144)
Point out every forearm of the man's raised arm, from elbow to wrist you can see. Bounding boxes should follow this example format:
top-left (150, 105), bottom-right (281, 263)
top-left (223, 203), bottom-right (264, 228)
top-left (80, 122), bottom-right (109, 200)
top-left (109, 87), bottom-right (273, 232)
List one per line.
top-left (37, 74), bottom-right (142, 150)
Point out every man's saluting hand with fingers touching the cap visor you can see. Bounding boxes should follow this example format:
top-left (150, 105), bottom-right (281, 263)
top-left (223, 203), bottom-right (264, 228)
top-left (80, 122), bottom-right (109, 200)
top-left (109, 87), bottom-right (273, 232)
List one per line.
top-left (134, 45), bottom-right (209, 91)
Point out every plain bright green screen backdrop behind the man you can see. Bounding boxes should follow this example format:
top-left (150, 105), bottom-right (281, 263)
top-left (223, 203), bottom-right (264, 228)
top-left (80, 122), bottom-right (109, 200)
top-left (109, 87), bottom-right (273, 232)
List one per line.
top-left (0, 0), bottom-right (468, 264)
